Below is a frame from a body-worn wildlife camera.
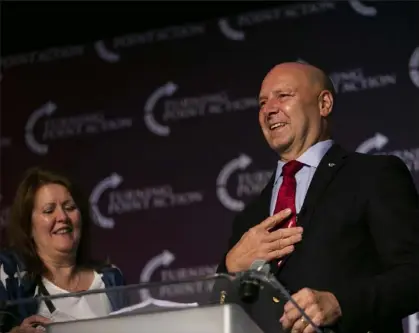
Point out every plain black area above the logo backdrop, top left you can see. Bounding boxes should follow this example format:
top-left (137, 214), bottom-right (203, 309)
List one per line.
top-left (1, 1), bottom-right (292, 56)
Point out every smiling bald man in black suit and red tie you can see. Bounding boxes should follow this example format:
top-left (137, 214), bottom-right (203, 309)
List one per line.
top-left (218, 63), bottom-right (419, 333)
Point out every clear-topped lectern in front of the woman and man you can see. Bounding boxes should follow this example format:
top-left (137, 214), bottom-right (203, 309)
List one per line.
top-left (1, 271), bottom-right (321, 333)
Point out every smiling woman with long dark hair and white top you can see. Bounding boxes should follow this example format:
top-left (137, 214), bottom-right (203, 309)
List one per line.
top-left (0, 168), bottom-right (124, 333)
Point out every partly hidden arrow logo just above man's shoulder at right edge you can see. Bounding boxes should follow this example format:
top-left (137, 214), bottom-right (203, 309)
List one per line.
top-left (356, 133), bottom-right (419, 172)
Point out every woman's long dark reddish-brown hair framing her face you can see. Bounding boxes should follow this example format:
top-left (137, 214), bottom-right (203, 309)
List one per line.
top-left (6, 167), bottom-right (95, 275)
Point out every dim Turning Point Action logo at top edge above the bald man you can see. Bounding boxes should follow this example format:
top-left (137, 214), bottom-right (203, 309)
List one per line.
top-left (218, 1), bottom-right (336, 41)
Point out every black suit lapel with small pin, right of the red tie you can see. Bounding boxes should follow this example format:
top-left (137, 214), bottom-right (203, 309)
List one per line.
top-left (298, 144), bottom-right (347, 228)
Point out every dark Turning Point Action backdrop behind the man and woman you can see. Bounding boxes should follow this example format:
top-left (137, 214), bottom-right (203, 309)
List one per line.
top-left (0, 1), bottom-right (419, 332)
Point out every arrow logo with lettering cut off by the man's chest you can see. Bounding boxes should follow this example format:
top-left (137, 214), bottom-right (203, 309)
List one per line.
top-left (216, 154), bottom-right (272, 212)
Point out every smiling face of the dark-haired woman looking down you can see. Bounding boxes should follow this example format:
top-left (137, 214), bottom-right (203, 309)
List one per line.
top-left (32, 184), bottom-right (82, 259)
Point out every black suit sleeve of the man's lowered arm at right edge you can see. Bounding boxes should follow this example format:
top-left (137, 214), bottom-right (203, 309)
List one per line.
top-left (334, 156), bottom-right (419, 331)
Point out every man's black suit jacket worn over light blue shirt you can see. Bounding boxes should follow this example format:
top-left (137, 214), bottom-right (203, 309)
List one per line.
top-left (218, 144), bottom-right (419, 333)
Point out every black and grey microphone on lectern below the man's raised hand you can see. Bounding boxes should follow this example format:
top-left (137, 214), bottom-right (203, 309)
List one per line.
top-left (239, 259), bottom-right (271, 303)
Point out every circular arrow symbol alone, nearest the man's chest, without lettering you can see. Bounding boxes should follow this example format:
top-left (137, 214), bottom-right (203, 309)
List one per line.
top-left (217, 154), bottom-right (252, 212)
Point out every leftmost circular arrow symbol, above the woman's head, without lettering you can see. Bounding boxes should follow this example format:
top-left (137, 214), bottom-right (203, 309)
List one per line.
top-left (25, 101), bottom-right (57, 155)
